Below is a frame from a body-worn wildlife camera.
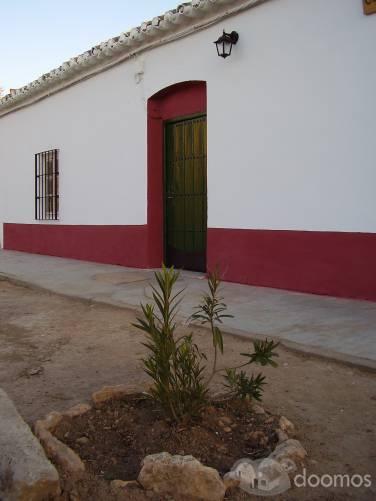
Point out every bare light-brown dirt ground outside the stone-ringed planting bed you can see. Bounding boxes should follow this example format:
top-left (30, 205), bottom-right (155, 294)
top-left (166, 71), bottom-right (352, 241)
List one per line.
top-left (0, 280), bottom-right (376, 501)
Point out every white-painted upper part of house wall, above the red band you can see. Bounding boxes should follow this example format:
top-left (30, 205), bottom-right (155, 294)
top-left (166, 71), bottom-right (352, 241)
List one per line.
top-left (0, 0), bottom-right (376, 232)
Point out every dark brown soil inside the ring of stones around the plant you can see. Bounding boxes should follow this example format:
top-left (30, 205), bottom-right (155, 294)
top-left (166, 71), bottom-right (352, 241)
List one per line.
top-left (54, 395), bottom-right (278, 480)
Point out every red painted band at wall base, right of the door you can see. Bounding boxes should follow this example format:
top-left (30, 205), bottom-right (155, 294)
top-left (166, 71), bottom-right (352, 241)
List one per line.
top-left (207, 228), bottom-right (376, 301)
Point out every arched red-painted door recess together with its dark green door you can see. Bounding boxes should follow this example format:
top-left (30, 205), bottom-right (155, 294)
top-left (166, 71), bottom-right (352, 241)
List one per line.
top-left (148, 81), bottom-right (207, 271)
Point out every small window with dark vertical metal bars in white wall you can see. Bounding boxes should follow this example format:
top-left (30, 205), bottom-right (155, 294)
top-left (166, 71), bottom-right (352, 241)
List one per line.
top-left (35, 150), bottom-right (59, 220)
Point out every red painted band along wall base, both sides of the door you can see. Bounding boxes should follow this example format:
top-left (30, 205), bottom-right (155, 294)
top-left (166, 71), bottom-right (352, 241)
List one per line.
top-left (4, 223), bottom-right (376, 301)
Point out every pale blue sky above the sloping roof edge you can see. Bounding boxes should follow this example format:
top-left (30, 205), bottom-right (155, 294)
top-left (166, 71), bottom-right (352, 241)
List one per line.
top-left (0, 0), bottom-right (179, 91)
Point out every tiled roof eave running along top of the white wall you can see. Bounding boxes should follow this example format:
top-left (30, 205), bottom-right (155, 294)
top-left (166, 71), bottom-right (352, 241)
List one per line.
top-left (0, 0), bottom-right (268, 117)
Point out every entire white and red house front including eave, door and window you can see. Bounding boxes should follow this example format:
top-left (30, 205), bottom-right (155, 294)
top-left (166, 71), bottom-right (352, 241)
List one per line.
top-left (0, 0), bottom-right (376, 300)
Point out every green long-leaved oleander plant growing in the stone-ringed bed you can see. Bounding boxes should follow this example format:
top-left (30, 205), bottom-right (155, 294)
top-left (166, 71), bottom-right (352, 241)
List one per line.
top-left (134, 266), bottom-right (278, 421)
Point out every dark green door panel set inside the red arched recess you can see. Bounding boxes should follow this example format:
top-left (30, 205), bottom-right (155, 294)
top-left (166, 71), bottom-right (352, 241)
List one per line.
top-left (165, 116), bottom-right (207, 271)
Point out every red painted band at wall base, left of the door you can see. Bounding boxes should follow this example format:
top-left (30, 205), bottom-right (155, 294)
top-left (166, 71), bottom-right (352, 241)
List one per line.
top-left (4, 223), bottom-right (148, 268)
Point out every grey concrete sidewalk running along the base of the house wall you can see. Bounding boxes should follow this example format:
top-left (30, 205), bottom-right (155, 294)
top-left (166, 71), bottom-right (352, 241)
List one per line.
top-left (0, 250), bottom-right (376, 369)
